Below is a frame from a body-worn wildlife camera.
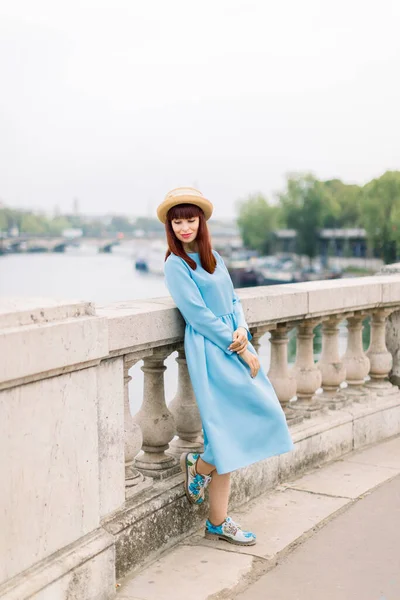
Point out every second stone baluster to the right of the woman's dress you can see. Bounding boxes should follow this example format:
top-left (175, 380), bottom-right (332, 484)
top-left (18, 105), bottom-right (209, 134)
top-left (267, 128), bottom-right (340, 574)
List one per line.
top-left (291, 319), bottom-right (324, 417)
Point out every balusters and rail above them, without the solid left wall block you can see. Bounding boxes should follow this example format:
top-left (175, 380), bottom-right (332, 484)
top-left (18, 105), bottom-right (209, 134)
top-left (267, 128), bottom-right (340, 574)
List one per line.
top-left (97, 277), bottom-right (400, 495)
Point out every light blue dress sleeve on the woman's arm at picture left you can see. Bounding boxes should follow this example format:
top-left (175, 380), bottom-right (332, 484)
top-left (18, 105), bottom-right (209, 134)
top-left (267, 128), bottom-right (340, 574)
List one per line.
top-left (164, 258), bottom-right (233, 355)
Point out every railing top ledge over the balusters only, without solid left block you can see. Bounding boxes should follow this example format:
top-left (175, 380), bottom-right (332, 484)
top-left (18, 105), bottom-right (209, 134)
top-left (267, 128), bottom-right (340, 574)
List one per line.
top-left (97, 275), bottom-right (400, 354)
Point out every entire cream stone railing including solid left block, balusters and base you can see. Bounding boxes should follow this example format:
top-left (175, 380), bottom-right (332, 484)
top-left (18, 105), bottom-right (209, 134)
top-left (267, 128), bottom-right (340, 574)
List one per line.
top-left (0, 275), bottom-right (400, 600)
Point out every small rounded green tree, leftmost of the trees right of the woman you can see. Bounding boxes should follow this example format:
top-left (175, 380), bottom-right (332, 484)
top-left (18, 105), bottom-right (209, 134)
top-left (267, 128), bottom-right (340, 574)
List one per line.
top-left (237, 194), bottom-right (279, 254)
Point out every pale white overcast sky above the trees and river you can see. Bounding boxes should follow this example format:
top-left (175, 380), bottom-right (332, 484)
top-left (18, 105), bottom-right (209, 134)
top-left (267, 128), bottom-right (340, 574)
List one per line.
top-left (0, 0), bottom-right (400, 218)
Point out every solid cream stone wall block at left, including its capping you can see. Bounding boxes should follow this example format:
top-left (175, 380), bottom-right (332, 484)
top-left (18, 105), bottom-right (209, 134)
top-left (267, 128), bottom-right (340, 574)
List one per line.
top-left (0, 301), bottom-right (119, 600)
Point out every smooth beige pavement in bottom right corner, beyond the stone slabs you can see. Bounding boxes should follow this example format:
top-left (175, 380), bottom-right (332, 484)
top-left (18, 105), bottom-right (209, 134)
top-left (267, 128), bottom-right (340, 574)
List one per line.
top-left (236, 476), bottom-right (400, 600)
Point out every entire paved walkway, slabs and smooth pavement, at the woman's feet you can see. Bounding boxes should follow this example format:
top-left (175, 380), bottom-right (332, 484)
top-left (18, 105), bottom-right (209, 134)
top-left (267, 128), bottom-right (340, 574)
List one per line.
top-left (117, 437), bottom-right (400, 600)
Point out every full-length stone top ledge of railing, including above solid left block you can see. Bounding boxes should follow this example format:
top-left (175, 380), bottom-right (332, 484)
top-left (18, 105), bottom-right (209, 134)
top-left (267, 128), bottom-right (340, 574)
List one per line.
top-left (0, 274), bottom-right (400, 388)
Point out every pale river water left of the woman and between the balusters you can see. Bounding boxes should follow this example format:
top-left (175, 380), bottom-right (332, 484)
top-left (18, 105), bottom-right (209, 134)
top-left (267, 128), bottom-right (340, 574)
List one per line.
top-left (0, 246), bottom-right (369, 412)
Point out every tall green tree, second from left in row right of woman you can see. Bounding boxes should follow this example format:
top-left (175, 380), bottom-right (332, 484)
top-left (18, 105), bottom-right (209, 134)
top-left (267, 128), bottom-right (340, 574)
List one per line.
top-left (279, 174), bottom-right (336, 262)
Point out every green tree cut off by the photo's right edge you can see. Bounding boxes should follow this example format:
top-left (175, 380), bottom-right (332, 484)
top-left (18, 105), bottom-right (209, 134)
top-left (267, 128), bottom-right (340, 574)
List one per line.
top-left (363, 171), bottom-right (400, 263)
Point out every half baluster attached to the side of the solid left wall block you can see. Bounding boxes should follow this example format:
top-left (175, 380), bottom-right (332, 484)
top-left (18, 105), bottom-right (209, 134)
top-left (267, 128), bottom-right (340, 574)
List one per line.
top-left (124, 355), bottom-right (144, 495)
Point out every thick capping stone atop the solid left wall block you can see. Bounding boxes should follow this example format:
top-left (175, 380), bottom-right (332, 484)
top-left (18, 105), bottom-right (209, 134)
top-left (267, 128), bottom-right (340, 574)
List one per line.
top-left (0, 300), bottom-right (109, 389)
